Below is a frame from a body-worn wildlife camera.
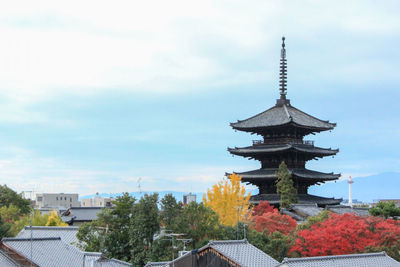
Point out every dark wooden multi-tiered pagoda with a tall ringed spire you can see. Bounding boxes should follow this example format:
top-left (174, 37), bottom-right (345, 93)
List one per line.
top-left (228, 37), bottom-right (341, 207)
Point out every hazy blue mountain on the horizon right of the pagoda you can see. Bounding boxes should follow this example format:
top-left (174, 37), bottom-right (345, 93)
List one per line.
top-left (308, 172), bottom-right (400, 202)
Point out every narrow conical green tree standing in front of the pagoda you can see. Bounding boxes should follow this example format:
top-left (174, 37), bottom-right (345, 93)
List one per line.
top-left (276, 161), bottom-right (298, 208)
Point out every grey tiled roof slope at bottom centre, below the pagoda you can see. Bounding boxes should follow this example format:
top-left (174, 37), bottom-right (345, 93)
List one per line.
top-left (208, 240), bottom-right (279, 267)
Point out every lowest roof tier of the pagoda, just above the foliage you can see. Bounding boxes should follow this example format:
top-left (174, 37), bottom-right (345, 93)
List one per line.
top-left (250, 194), bottom-right (343, 207)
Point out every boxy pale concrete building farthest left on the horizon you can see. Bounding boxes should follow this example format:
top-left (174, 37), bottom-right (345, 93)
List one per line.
top-left (36, 193), bottom-right (80, 210)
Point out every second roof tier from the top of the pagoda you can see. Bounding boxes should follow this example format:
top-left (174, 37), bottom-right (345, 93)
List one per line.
top-left (228, 144), bottom-right (339, 158)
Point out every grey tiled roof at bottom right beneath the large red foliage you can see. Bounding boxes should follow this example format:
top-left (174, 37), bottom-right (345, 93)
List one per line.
top-left (279, 252), bottom-right (400, 267)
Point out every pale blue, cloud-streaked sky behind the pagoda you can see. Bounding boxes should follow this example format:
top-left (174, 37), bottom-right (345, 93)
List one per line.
top-left (0, 0), bottom-right (400, 195)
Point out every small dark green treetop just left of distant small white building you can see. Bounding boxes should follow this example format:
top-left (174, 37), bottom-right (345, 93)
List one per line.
top-left (160, 194), bottom-right (183, 229)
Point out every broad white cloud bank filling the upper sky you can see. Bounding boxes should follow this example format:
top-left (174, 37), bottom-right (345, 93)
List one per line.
top-left (0, 1), bottom-right (400, 110)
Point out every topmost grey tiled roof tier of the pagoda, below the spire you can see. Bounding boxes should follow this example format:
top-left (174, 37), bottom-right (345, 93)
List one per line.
top-left (230, 104), bottom-right (336, 133)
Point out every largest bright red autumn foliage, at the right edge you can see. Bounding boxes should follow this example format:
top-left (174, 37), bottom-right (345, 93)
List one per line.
top-left (290, 214), bottom-right (400, 256)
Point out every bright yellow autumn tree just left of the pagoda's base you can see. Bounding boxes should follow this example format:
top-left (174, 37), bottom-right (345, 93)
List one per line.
top-left (203, 173), bottom-right (250, 226)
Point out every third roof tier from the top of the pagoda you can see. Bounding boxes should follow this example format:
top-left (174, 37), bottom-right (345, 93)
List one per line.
top-left (226, 168), bottom-right (340, 182)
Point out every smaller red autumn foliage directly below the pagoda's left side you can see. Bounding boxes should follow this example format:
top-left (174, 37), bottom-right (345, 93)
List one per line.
top-left (251, 209), bottom-right (297, 235)
